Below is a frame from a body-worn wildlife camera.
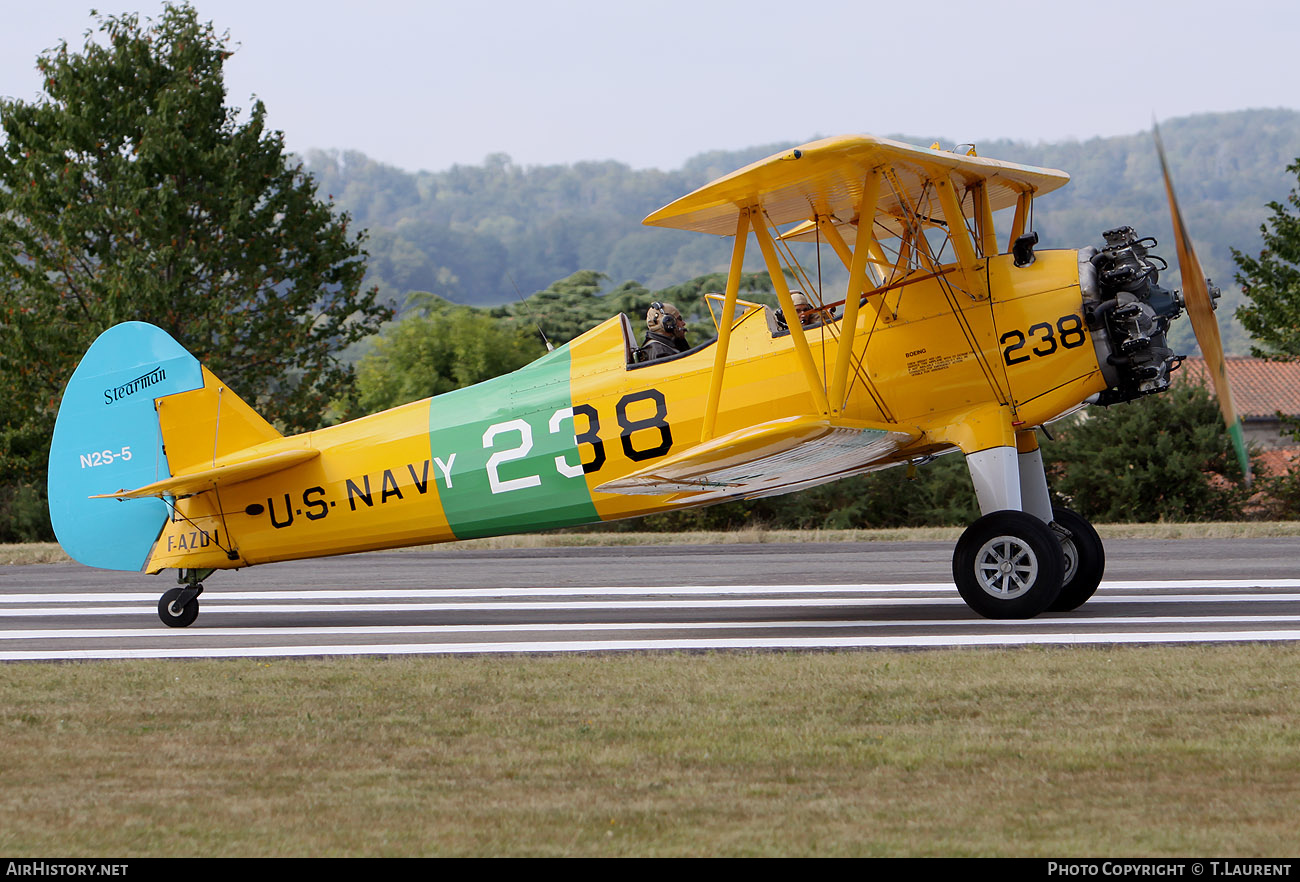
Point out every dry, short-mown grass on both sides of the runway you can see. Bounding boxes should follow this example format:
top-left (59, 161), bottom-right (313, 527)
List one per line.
top-left (0, 524), bottom-right (1300, 859)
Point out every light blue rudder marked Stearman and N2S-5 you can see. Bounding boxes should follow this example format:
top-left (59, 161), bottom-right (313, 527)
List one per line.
top-left (49, 321), bottom-right (203, 571)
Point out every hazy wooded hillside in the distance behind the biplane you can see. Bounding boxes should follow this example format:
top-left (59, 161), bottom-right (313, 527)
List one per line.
top-left (304, 109), bottom-right (1300, 354)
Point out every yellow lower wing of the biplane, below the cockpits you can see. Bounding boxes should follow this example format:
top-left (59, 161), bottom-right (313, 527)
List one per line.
top-left (595, 416), bottom-right (919, 502)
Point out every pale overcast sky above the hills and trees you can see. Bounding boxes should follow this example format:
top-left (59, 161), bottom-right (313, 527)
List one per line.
top-left (0, 0), bottom-right (1300, 170)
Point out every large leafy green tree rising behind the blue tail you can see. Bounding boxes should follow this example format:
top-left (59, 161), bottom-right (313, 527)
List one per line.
top-left (0, 5), bottom-right (389, 538)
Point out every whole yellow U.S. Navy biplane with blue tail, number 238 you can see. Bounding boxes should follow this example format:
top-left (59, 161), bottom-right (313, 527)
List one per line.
top-left (49, 137), bottom-right (1245, 627)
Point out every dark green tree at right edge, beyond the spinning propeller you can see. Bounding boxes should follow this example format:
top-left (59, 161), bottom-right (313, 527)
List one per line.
top-left (1232, 159), bottom-right (1300, 360)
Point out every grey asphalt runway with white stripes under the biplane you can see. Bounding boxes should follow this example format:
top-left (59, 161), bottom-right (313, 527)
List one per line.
top-left (0, 539), bottom-right (1300, 661)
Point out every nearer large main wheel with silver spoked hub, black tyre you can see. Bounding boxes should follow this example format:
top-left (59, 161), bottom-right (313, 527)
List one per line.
top-left (953, 511), bottom-right (1065, 619)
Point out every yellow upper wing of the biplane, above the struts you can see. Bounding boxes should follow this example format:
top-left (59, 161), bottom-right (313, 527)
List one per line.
top-left (644, 135), bottom-right (1070, 235)
